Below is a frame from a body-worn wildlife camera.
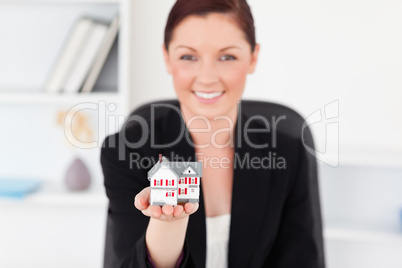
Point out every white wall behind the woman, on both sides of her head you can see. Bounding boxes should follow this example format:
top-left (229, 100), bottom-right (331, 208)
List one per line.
top-left (131, 0), bottom-right (402, 166)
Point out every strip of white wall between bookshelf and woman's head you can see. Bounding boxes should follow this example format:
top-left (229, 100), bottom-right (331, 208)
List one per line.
top-left (131, 0), bottom-right (175, 108)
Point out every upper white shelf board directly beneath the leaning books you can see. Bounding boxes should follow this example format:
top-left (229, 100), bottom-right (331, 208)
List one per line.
top-left (0, 92), bottom-right (121, 104)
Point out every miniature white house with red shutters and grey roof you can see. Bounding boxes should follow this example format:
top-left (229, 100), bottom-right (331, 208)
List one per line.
top-left (148, 155), bottom-right (202, 206)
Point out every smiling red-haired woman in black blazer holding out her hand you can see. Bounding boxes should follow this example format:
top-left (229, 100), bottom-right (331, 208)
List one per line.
top-left (101, 0), bottom-right (324, 268)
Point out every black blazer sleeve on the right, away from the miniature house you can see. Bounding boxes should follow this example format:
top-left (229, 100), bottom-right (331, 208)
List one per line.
top-left (264, 133), bottom-right (325, 268)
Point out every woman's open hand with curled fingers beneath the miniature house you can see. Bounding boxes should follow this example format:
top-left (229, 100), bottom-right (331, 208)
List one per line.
top-left (134, 186), bottom-right (199, 222)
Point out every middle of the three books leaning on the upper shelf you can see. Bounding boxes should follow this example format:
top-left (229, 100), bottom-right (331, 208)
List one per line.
top-left (63, 21), bottom-right (108, 93)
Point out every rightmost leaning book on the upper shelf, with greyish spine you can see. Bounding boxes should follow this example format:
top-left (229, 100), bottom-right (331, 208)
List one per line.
top-left (81, 16), bottom-right (120, 92)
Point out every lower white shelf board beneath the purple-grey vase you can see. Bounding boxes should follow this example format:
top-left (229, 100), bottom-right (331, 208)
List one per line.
top-left (0, 182), bottom-right (108, 208)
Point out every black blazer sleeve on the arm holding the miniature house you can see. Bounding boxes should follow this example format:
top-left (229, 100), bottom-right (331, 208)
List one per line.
top-left (100, 134), bottom-right (191, 268)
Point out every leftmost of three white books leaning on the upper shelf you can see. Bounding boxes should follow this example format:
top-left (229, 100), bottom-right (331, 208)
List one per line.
top-left (45, 18), bottom-right (93, 93)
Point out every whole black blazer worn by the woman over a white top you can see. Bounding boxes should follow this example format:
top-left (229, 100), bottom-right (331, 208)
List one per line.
top-left (101, 100), bottom-right (325, 268)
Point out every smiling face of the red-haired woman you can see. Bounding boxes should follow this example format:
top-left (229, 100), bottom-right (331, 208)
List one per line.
top-left (163, 13), bottom-right (259, 119)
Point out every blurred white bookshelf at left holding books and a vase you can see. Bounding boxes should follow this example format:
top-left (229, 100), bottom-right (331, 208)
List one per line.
top-left (0, 0), bottom-right (133, 267)
